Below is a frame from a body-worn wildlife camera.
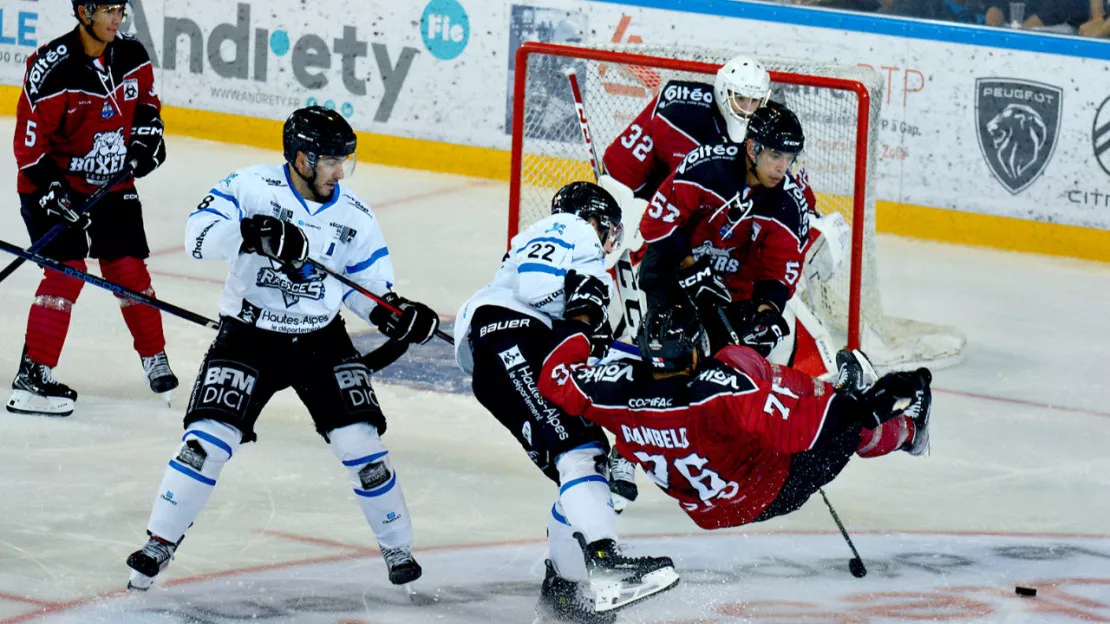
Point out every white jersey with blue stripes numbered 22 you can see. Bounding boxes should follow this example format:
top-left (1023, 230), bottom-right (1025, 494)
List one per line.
top-left (455, 212), bottom-right (614, 373)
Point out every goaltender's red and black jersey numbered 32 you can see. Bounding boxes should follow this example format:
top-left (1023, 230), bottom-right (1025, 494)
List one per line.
top-left (602, 80), bottom-right (817, 211)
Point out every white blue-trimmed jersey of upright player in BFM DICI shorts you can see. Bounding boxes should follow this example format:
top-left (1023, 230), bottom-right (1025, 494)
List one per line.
top-left (185, 164), bottom-right (394, 334)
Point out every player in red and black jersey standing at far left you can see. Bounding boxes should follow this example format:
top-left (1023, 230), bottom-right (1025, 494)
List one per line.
top-left (7, 0), bottom-right (178, 416)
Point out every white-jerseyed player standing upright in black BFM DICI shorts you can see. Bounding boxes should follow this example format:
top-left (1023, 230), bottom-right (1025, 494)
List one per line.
top-left (121, 107), bottom-right (438, 590)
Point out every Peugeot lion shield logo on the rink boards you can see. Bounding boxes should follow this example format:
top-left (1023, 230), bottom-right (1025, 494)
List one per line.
top-left (975, 78), bottom-right (1063, 194)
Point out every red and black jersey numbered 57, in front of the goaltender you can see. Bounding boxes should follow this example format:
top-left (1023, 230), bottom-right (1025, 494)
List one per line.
top-left (639, 142), bottom-right (809, 309)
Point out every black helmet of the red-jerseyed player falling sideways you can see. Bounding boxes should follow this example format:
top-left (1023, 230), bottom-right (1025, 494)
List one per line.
top-left (636, 304), bottom-right (709, 373)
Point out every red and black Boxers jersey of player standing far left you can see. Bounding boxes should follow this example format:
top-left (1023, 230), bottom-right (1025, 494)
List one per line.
top-left (14, 29), bottom-right (161, 194)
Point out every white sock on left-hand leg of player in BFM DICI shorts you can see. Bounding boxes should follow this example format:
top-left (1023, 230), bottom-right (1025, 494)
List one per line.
top-left (147, 420), bottom-right (242, 544)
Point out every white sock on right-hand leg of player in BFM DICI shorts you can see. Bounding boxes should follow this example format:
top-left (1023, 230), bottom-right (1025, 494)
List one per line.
top-left (327, 423), bottom-right (413, 548)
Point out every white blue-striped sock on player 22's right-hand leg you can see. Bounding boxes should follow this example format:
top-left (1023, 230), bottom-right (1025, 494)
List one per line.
top-left (555, 443), bottom-right (617, 544)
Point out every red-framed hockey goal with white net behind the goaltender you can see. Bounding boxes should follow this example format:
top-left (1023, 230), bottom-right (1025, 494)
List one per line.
top-left (508, 42), bottom-right (966, 369)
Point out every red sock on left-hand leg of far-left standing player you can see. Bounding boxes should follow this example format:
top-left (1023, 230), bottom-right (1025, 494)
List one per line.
top-left (26, 260), bottom-right (85, 369)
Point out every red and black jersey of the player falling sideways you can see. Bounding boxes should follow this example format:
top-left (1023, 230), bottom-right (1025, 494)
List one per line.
top-left (539, 333), bottom-right (835, 529)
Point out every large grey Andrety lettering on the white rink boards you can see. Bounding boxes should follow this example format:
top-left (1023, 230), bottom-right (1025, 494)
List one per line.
top-left (122, 0), bottom-right (417, 122)
